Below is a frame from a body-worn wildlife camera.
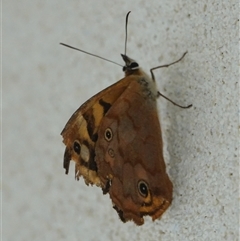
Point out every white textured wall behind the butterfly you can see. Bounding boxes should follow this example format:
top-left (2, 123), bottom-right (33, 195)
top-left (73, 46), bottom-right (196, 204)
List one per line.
top-left (2, 0), bottom-right (239, 241)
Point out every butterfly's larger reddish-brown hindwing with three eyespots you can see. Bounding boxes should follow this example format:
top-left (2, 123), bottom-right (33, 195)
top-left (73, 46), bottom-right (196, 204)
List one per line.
top-left (96, 77), bottom-right (172, 225)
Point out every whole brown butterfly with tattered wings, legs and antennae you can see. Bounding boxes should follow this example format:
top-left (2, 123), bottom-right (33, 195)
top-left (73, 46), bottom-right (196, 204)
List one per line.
top-left (61, 12), bottom-right (191, 225)
